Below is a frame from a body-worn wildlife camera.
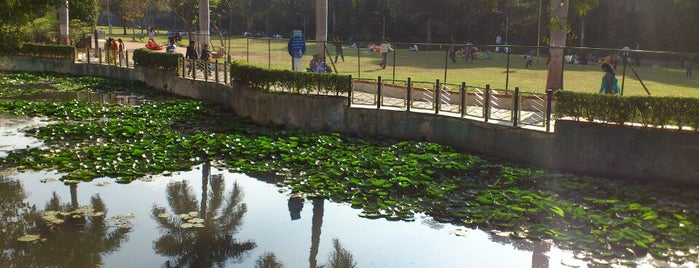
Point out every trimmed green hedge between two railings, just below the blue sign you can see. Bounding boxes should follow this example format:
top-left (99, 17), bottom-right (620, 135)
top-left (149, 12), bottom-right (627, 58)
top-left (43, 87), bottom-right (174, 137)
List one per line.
top-left (231, 61), bottom-right (351, 95)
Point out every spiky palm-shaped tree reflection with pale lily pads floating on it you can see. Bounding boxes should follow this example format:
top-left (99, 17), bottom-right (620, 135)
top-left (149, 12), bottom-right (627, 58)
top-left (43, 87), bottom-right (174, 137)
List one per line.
top-left (152, 165), bottom-right (255, 267)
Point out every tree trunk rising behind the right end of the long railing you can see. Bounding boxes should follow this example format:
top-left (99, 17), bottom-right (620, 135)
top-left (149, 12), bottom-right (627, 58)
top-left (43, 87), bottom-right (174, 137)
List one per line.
top-left (546, 0), bottom-right (569, 90)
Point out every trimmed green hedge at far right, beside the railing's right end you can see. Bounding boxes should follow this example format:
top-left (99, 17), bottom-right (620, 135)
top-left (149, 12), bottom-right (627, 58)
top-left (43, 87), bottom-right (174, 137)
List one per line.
top-left (555, 90), bottom-right (699, 130)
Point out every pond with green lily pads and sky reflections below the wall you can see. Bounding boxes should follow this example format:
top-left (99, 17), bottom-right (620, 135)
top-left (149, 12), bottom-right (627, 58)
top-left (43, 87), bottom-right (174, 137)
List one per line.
top-left (0, 74), bottom-right (699, 267)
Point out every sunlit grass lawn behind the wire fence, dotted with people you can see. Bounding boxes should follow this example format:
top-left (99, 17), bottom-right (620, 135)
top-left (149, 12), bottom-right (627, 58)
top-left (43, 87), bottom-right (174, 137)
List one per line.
top-left (100, 27), bottom-right (699, 98)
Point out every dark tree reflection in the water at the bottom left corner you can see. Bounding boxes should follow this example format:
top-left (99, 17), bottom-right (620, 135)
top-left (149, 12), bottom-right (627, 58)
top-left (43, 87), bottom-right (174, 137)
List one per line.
top-left (0, 174), bottom-right (130, 267)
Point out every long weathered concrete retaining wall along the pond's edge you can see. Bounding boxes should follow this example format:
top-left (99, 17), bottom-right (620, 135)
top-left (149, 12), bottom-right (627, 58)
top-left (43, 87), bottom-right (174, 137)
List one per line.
top-left (0, 57), bottom-right (699, 185)
